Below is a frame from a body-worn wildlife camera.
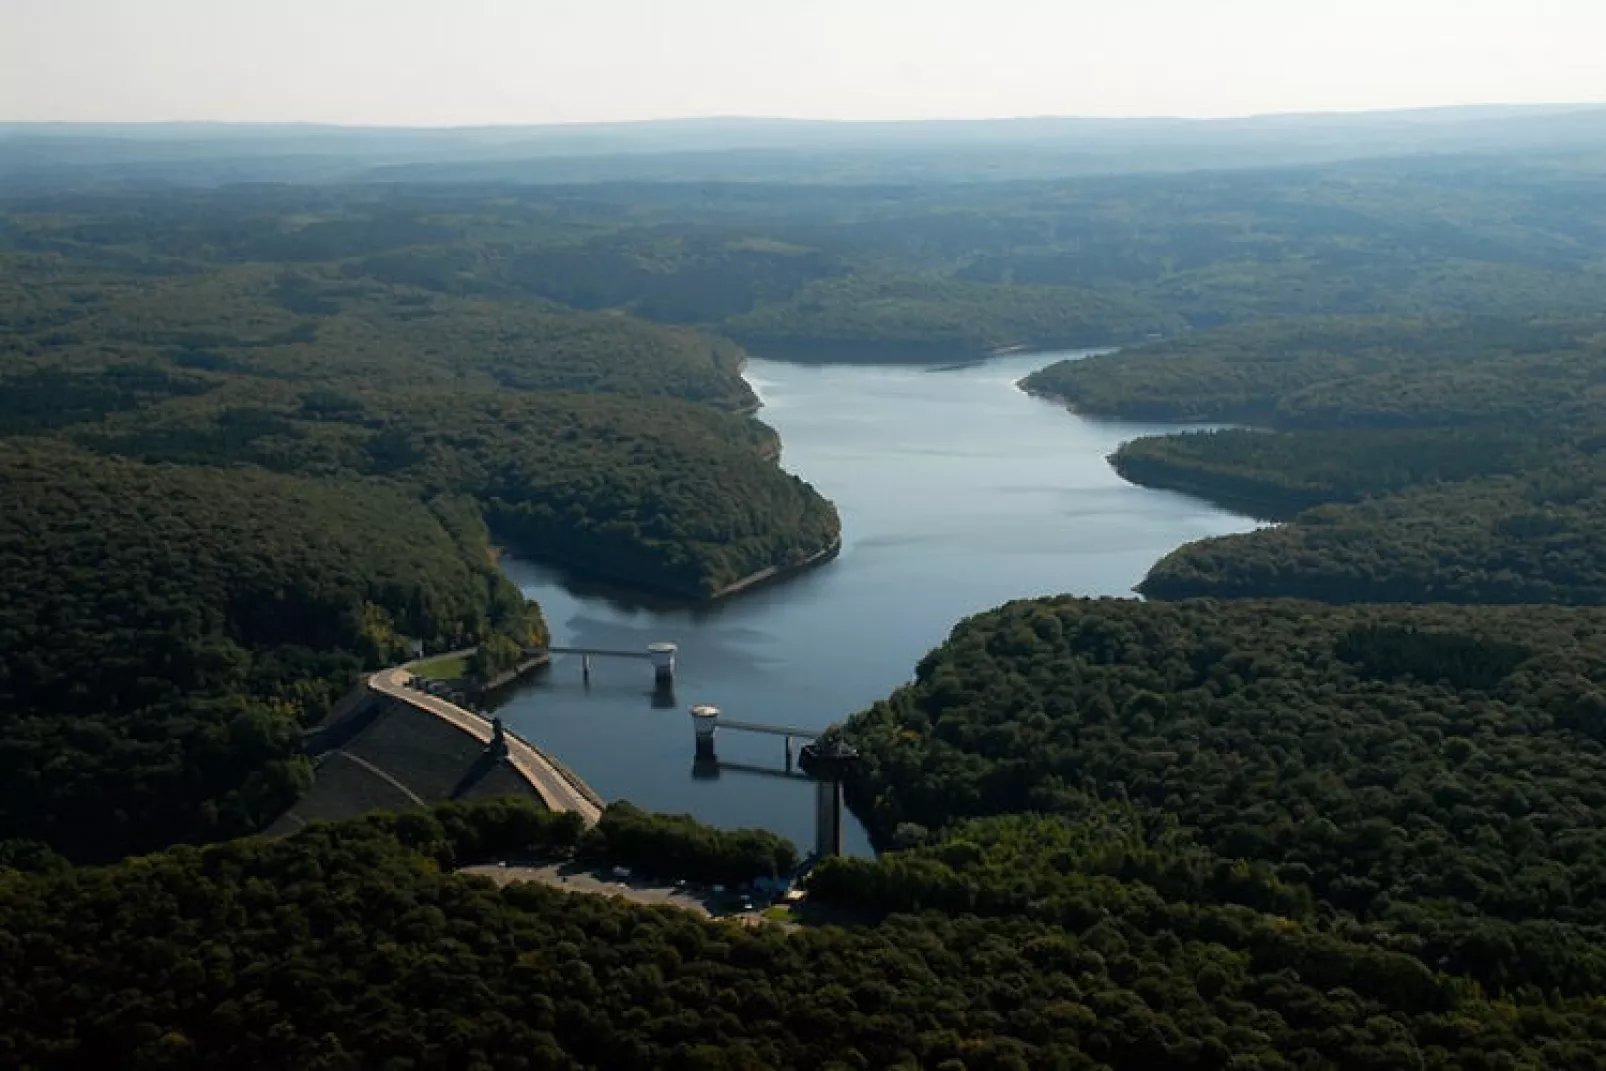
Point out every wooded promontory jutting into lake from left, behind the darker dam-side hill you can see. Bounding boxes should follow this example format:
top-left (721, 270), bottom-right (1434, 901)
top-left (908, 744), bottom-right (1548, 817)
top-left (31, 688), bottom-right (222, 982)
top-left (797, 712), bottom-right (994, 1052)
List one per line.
top-left (0, 228), bottom-right (835, 597)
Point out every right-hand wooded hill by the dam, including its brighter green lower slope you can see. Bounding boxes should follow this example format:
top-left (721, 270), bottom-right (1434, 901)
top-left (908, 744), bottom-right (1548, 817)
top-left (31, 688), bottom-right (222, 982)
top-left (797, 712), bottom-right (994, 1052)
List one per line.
top-left (814, 597), bottom-right (1606, 1040)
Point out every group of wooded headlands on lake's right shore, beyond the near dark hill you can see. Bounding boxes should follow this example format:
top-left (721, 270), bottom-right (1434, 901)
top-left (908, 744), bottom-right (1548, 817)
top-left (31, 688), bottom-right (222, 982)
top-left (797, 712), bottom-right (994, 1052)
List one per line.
top-left (1026, 315), bottom-right (1606, 604)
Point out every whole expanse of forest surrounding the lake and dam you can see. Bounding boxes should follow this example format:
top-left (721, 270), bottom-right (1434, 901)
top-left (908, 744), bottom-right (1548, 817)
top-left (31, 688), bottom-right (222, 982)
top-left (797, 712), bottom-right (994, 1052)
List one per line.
top-left (9, 135), bottom-right (1606, 1071)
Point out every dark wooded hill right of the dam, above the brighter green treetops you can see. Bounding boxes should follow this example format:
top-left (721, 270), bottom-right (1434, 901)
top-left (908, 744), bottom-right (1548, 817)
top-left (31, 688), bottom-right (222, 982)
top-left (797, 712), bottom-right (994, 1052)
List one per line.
top-left (848, 597), bottom-right (1606, 923)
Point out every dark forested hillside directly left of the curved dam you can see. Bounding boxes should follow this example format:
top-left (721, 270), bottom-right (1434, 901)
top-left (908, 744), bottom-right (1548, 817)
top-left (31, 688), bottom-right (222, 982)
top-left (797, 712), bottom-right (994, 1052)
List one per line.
top-left (0, 440), bottom-right (544, 859)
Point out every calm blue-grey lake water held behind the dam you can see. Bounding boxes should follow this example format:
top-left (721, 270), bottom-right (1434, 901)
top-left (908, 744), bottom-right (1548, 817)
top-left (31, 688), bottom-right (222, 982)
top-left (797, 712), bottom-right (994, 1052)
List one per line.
top-left (501, 353), bottom-right (1254, 853)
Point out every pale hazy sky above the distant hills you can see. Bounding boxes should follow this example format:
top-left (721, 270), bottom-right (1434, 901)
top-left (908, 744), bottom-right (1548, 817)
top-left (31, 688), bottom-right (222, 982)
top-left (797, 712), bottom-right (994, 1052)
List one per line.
top-left (0, 0), bottom-right (1606, 124)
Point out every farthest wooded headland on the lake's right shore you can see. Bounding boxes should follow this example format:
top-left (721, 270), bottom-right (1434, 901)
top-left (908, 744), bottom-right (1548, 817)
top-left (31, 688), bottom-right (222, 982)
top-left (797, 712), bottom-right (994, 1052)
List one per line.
top-left (1026, 310), bottom-right (1606, 430)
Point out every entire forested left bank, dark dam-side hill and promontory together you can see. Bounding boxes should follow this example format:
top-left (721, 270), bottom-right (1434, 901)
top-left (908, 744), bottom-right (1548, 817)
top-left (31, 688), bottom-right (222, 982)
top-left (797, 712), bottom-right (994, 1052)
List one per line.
top-left (0, 191), bottom-right (837, 861)
